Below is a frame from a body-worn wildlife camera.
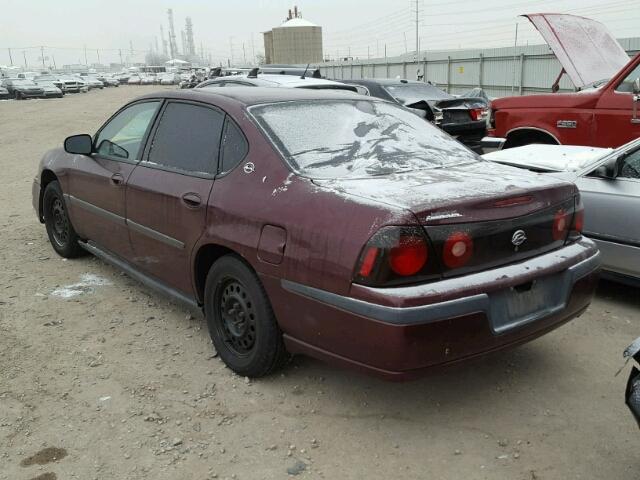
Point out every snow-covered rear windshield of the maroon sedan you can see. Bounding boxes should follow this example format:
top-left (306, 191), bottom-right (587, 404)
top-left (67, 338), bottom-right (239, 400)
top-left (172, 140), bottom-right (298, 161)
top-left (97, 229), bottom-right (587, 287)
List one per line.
top-left (251, 100), bottom-right (479, 179)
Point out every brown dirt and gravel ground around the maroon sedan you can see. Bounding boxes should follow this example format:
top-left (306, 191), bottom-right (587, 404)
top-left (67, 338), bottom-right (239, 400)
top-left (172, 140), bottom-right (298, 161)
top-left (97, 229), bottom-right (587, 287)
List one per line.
top-left (0, 87), bottom-right (640, 480)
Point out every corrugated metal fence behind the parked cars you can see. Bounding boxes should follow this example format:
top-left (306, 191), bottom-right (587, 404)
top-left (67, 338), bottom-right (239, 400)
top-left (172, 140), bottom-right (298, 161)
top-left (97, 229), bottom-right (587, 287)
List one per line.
top-left (321, 37), bottom-right (640, 97)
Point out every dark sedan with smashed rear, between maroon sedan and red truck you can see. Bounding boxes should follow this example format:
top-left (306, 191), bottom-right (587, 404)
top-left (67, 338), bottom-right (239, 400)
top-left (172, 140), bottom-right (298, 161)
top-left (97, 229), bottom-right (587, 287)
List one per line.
top-left (341, 79), bottom-right (488, 153)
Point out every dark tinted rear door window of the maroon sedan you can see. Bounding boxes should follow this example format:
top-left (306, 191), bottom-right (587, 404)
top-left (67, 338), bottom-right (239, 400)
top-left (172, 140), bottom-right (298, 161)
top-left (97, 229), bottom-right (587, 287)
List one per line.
top-left (147, 102), bottom-right (224, 175)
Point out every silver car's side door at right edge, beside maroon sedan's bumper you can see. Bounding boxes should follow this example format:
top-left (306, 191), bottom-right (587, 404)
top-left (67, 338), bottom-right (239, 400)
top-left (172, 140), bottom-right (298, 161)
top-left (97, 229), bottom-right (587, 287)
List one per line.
top-left (576, 150), bottom-right (640, 276)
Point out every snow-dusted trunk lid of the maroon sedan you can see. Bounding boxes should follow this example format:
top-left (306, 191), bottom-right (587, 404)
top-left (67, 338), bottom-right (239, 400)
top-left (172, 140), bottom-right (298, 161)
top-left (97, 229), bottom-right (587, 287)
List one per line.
top-left (313, 161), bottom-right (576, 224)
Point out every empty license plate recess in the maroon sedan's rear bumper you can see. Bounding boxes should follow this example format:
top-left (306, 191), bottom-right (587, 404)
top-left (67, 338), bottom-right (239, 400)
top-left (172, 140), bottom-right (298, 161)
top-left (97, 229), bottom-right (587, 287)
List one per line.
top-left (489, 274), bottom-right (568, 334)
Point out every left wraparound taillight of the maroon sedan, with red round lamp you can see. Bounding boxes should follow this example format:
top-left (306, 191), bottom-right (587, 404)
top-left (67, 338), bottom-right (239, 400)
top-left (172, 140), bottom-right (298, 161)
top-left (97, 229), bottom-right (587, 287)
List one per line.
top-left (354, 227), bottom-right (440, 287)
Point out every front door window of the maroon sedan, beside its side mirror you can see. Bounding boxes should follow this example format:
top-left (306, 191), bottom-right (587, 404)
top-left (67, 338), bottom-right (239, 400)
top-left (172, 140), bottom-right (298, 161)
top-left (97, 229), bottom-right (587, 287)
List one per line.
top-left (95, 101), bottom-right (160, 160)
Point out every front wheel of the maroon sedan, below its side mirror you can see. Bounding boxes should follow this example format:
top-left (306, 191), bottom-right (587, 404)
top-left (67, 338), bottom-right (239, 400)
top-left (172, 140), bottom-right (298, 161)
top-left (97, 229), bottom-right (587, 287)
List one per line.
top-left (42, 180), bottom-right (84, 258)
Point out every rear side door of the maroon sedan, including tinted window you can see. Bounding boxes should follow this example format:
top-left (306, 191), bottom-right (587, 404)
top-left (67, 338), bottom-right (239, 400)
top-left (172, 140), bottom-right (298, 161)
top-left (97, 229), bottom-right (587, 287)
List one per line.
top-left (127, 101), bottom-right (225, 295)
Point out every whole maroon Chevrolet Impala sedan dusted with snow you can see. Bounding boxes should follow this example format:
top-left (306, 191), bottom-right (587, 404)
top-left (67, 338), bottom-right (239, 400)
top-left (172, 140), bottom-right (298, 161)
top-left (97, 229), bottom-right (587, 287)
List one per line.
top-left (33, 88), bottom-right (600, 378)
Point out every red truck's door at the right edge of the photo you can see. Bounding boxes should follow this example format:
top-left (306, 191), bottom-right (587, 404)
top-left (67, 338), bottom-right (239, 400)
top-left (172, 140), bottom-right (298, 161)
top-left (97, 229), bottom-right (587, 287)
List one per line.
top-left (594, 64), bottom-right (640, 148)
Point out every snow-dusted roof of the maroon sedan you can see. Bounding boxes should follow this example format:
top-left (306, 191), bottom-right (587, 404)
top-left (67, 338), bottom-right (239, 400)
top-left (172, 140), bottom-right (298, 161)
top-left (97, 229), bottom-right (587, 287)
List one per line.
top-left (139, 87), bottom-right (372, 106)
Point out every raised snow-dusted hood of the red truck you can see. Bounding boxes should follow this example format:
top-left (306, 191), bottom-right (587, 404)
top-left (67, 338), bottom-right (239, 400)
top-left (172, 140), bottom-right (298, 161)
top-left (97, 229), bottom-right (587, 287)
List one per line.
top-left (523, 13), bottom-right (629, 88)
